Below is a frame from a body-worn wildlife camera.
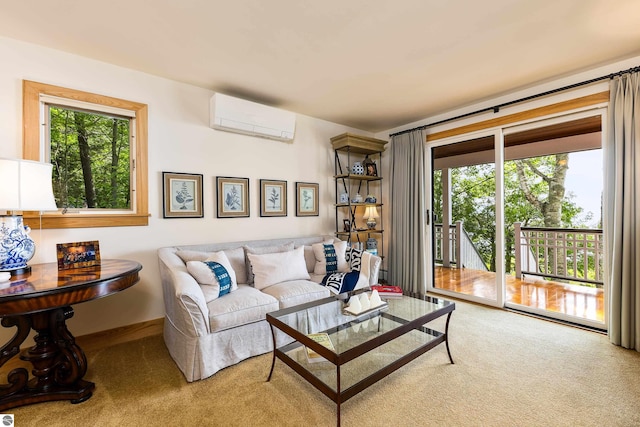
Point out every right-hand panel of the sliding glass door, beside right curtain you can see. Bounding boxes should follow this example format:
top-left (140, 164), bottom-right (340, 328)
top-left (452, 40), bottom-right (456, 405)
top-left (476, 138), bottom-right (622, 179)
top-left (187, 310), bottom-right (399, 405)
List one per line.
top-left (504, 111), bottom-right (606, 329)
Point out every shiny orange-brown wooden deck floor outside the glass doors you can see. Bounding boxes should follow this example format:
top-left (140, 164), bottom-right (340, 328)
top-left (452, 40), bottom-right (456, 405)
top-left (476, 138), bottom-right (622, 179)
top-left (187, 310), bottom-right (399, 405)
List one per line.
top-left (434, 266), bottom-right (605, 323)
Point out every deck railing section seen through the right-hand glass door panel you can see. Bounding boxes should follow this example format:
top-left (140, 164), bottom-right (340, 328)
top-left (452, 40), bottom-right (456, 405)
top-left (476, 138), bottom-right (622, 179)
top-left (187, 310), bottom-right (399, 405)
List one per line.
top-left (514, 222), bottom-right (604, 287)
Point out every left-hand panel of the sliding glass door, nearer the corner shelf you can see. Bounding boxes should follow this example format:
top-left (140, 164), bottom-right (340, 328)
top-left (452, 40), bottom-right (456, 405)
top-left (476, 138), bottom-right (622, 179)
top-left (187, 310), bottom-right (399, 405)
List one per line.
top-left (429, 133), bottom-right (503, 306)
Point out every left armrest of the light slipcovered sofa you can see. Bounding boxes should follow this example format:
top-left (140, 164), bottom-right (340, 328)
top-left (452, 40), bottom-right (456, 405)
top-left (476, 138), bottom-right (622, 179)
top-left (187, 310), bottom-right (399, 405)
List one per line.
top-left (158, 248), bottom-right (210, 337)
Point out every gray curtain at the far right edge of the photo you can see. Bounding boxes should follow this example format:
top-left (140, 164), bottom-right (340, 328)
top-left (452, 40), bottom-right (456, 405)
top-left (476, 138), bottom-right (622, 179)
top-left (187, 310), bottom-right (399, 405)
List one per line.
top-left (603, 73), bottom-right (640, 351)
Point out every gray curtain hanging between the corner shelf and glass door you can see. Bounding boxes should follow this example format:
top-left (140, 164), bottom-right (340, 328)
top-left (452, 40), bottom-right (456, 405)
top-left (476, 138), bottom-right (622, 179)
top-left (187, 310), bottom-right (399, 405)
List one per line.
top-left (388, 130), bottom-right (427, 295)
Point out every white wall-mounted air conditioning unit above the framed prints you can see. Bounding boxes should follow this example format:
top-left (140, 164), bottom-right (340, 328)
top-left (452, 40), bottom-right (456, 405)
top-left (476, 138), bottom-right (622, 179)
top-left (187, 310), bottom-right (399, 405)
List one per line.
top-left (211, 93), bottom-right (296, 142)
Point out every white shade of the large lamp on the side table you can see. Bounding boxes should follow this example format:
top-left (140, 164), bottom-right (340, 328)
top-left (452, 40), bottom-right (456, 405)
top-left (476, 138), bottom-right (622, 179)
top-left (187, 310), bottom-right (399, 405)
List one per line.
top-left (0, 159), bottom-right (58, 211)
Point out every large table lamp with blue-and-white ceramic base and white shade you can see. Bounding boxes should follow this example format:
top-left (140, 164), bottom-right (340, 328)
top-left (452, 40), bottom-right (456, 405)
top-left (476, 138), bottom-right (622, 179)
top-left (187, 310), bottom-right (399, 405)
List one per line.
top-left (0, 158), bottom-right (58, 275)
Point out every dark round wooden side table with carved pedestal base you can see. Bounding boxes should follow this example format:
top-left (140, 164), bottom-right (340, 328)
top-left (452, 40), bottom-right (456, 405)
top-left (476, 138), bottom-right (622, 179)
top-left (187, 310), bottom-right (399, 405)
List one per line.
top-left (0, 259), bottom-right (142, 411)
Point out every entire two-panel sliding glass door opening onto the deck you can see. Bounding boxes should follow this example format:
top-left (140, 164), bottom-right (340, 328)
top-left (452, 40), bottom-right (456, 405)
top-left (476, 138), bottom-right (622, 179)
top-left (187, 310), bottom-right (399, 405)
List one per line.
top-left (427, 109), bottom-right (606, 329)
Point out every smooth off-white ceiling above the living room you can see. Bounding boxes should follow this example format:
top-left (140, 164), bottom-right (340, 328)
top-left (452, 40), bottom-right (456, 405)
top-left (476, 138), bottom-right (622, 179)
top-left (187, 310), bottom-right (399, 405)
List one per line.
top-left (0, 0), bottom-right (640, 132)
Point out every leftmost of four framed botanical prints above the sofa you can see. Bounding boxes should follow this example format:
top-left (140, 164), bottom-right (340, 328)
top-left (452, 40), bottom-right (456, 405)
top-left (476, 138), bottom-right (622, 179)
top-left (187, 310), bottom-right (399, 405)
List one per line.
top-left (162, 172), bottom-right (204, 218)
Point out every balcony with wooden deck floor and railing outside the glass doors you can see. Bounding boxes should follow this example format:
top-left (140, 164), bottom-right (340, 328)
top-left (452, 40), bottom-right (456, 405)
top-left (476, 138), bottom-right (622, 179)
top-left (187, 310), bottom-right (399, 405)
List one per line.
top-left (434, 223), bottom-right (605, 324)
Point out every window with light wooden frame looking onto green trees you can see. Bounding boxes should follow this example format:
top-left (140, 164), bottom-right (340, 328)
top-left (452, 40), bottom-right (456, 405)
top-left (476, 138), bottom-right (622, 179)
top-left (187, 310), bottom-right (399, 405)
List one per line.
top-left (23, 80), bottom-right (149, 228)
